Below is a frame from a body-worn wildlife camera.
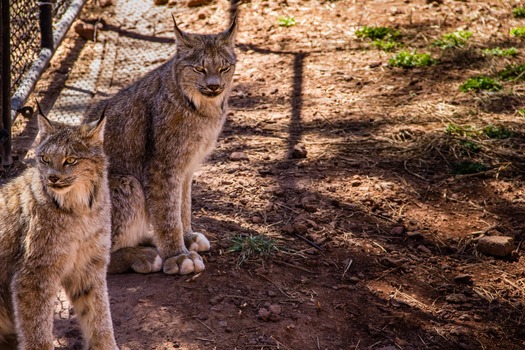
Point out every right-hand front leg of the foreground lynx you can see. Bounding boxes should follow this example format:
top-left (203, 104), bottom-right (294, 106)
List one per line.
top-left (64, 257), bottom-right (118, 350)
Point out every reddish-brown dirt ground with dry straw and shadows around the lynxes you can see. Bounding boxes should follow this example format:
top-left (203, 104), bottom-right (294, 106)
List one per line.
top-left (3, 0), bottom-right (525, 350)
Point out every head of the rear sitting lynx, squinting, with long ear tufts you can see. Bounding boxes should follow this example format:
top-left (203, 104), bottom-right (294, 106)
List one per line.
top-left (173, 18), bottom-right (237, 107)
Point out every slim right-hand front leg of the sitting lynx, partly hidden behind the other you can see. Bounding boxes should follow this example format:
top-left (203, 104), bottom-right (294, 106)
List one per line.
top-left (181, 174), bottom-right (210, 252)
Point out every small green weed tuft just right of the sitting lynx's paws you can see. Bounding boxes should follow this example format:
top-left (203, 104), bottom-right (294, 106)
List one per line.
top-left (229, 235), bottom-right (278, 265)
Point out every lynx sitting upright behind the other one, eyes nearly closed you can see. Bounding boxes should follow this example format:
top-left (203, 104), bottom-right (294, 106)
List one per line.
top-left (88, 19), bottom-right (237, 275)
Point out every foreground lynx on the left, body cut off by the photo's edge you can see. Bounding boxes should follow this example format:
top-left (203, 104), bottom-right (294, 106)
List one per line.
top-left (0, 108), bottom-right (117, 350)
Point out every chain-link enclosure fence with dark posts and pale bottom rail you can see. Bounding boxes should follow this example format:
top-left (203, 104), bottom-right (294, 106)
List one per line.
top-left (0, 0), bottom-right (86, 166)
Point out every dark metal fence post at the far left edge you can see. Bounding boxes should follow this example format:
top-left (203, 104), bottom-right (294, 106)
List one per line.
top-left (0, 0), bottom-right (13, 166)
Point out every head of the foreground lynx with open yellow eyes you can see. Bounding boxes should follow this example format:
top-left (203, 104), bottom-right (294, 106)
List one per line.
top-left (36, 107), bottom-right (107, 209)
